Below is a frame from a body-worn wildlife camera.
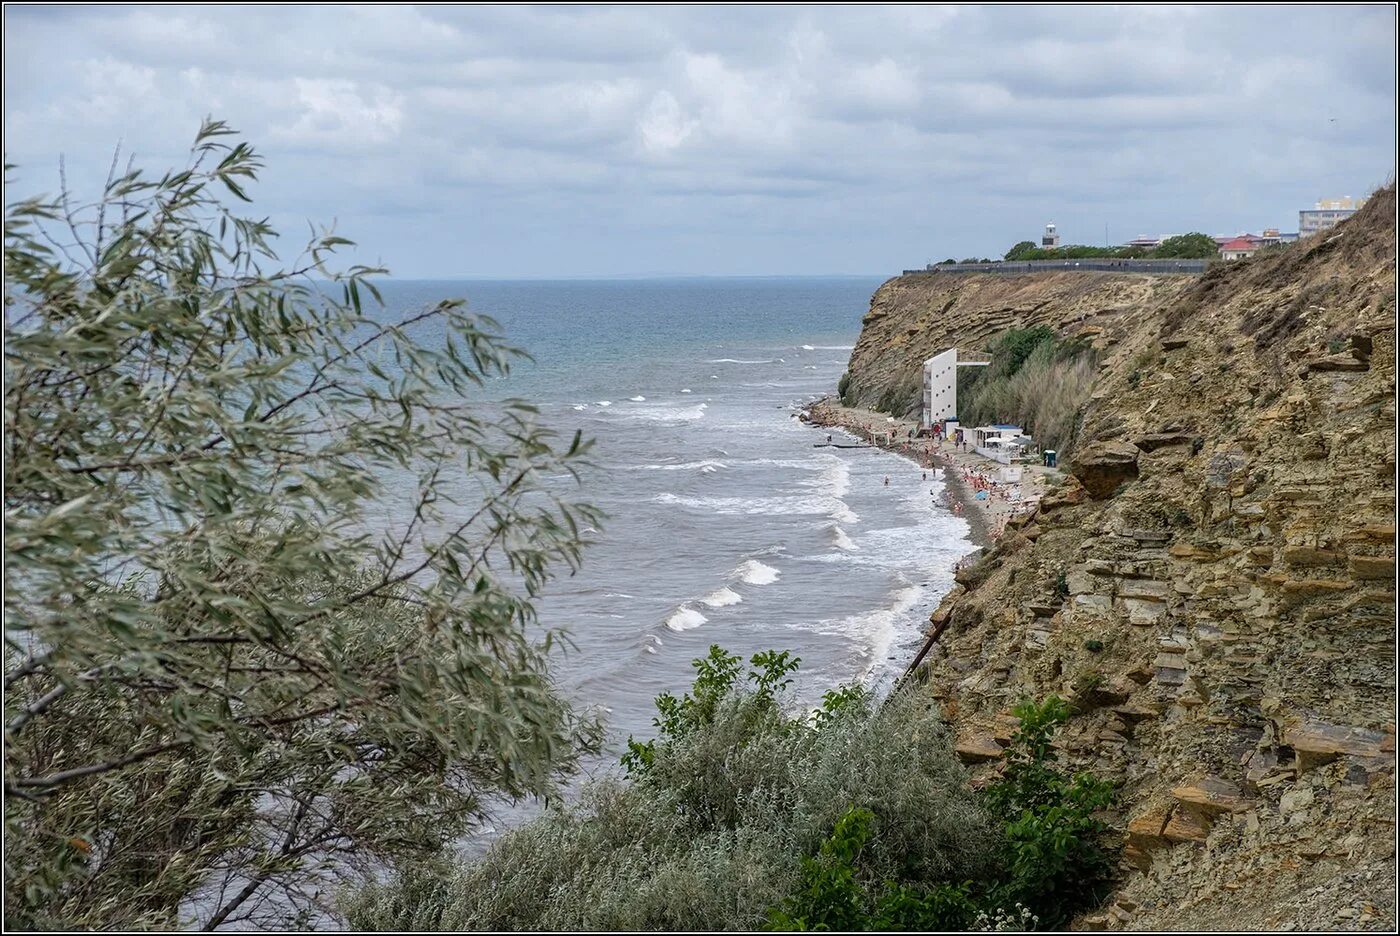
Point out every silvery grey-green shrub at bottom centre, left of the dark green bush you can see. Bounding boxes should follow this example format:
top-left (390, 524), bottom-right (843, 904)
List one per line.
top-left (344, 648), bottom-right (995, 930)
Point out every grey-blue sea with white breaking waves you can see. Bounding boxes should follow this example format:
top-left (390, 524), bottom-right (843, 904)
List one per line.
top-left (366, 277), bottom-right (973, 833)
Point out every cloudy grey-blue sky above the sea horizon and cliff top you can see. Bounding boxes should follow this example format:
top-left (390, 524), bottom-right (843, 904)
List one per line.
top-left (4, 4), bottom-right (1396, 278)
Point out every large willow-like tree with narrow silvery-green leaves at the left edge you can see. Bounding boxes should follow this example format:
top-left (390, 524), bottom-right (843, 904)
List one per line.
top-left (4, 122), bottom-right (598, 929)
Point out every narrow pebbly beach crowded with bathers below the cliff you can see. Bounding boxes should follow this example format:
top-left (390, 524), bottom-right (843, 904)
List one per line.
top-left (801, 397), bottom-right (1044, 548)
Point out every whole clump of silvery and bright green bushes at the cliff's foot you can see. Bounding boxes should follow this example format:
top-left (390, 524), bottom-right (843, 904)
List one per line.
top-left (344, 657), bottom-right (1113, 930)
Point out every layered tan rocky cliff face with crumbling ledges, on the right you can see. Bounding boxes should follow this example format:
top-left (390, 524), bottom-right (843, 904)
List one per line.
top-left (851, 187), bottom-right (1396, 929)
